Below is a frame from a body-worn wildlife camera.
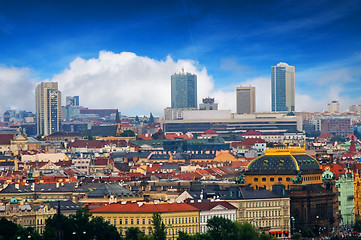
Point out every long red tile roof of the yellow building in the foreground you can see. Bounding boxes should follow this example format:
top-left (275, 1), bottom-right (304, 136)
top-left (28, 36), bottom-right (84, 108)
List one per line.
top-left (90, 203), bottom-right (199, 213)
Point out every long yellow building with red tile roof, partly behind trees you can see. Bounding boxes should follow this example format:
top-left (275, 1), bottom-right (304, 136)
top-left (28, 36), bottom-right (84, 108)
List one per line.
top-left (90, 202), bottom-right (199, 239)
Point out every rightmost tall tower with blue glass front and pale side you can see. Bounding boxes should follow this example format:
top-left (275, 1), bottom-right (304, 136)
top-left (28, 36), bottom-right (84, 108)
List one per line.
top-left (271, 62), bottom-right (295, 112)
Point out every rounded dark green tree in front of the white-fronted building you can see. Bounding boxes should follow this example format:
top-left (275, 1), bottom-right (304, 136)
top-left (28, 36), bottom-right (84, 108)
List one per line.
top-left (207, 217), bottom-right (237, 240)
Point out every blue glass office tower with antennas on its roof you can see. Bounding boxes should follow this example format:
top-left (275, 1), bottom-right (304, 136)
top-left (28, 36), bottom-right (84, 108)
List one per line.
top-left (171, 69), bottom-right (197, 108)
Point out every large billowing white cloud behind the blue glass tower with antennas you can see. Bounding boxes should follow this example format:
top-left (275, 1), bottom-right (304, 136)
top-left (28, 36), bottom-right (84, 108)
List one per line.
top-left (52, 51), bottom-right (214, 115)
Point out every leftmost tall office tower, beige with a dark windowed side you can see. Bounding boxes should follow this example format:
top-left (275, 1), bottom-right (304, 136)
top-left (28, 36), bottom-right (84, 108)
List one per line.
top-left (35, 82), bottom-right (61, 136)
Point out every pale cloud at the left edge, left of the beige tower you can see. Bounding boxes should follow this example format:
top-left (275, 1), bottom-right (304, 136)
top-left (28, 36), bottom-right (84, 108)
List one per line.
top-left (0, 66), bottom-right (35, 116)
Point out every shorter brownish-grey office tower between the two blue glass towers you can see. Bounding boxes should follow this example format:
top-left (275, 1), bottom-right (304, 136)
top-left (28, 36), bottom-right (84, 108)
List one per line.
top-left (236, 86), bottom-right (256, 114)
